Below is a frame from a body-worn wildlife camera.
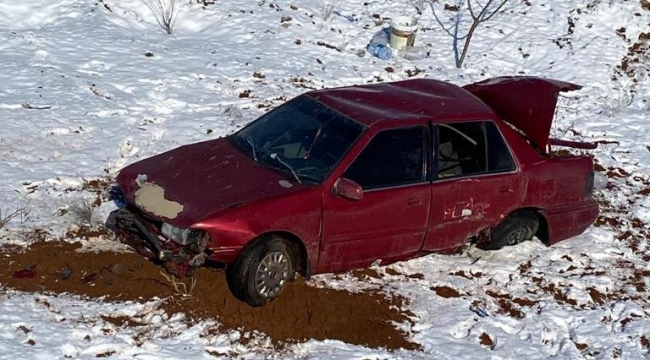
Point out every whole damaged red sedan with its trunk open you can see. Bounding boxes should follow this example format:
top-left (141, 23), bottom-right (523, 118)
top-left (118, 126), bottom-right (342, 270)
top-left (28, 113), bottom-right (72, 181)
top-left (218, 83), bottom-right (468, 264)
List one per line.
top-left (107, 77), bottom-right (598, 306)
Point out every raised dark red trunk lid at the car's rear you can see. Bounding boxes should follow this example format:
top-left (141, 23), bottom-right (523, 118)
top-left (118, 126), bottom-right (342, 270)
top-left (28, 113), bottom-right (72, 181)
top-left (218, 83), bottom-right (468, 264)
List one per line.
top-left (463, 76), bottom-right (582, 151)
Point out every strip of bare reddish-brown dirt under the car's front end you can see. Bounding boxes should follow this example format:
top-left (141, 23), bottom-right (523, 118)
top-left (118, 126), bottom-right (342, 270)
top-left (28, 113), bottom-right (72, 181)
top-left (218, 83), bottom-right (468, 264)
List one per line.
top-left (0, 242), bottom-right (418, 349)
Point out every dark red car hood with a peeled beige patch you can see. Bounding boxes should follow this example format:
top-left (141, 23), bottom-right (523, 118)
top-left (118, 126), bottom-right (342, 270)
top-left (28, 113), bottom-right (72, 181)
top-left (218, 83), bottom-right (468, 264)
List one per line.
top-left (117, 138), bottom-right (303, 227)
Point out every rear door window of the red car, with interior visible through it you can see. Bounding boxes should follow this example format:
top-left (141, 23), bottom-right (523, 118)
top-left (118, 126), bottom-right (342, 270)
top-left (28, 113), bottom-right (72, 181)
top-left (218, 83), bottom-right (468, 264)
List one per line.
top-left (437, 121), bottom-right (515, 178)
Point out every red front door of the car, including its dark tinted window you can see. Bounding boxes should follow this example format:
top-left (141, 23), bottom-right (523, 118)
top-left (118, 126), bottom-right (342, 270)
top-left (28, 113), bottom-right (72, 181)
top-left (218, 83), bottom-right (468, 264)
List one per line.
top-left (320, 126), bottom-right (431, 272)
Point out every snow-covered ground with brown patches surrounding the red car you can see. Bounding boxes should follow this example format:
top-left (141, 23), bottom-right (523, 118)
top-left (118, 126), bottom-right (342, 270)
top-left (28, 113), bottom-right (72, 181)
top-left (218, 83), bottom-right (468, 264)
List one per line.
top-left (0, 0), bottom-right (650, 359)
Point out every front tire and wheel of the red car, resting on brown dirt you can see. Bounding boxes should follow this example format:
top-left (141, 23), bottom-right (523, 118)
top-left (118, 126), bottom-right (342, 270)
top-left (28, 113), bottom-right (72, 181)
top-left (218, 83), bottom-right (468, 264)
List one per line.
top-left (226, 236), bottom-right (295, 307)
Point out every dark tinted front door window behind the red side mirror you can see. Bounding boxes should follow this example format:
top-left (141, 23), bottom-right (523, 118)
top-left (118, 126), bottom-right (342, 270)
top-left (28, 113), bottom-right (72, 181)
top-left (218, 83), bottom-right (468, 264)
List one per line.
top-left (344, 127), bottom-right (427, 190)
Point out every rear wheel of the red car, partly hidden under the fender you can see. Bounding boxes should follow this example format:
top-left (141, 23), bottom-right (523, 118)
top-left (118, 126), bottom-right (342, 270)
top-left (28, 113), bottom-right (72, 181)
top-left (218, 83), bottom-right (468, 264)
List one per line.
top-left (478, 210), bottom-right (539, 250)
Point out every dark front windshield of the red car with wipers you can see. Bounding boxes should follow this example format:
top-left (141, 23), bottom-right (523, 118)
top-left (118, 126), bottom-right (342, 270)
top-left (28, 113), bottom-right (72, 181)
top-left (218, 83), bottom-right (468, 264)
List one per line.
top-left (234, 96), bottom-right (364, 183)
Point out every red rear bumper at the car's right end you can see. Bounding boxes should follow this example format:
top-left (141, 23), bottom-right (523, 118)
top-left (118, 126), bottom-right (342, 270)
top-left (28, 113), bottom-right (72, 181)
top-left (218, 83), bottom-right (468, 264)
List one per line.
top-left (541, 199), bottom-right (599, 245)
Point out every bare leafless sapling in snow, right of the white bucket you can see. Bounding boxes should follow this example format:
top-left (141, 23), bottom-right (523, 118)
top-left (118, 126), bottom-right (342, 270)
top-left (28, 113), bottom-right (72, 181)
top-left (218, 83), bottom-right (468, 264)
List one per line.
top-left (429, 0), bottom-right (508, 68)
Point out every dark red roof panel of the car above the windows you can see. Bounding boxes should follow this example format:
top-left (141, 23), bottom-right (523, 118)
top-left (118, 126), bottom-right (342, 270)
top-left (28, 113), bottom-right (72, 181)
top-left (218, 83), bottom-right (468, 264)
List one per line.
top-left (305, 79), bottom-right (496, 126)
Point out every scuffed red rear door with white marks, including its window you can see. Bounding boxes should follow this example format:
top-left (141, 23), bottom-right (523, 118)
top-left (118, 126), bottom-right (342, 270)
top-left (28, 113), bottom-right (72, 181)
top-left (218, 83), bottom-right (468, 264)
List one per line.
top-left (424, 121), bottom-right (525, 250)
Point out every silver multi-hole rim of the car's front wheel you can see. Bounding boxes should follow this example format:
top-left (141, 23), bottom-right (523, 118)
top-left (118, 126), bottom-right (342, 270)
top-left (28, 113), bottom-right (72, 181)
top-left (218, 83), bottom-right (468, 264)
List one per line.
top-left (255, 251), bottom-right (291, 298)
